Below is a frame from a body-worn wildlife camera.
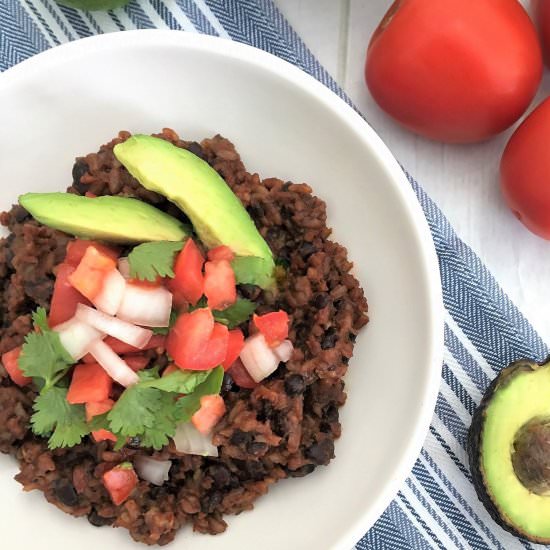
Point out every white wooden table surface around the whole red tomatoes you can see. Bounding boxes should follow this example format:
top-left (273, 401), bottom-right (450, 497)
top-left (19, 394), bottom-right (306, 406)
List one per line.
top-left (276, 0), bottom-right (550, 350)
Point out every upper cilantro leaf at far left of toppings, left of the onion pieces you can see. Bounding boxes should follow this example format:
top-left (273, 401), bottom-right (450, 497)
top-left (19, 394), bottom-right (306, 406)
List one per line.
top-left (19, 330), bottom-right (74, 390)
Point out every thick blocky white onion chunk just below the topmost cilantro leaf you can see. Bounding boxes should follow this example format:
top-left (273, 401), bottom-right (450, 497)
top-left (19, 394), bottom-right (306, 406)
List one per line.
top-left (117, 283), bottom-right (172, 327)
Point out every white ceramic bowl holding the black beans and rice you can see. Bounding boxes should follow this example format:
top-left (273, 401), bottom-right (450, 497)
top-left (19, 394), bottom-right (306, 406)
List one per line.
top-left (0, 31), bottom-right (442, 550)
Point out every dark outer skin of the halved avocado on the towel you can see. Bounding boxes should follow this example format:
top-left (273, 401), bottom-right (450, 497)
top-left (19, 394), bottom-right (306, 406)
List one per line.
top-left (466, 357), bottom-right (550, 544)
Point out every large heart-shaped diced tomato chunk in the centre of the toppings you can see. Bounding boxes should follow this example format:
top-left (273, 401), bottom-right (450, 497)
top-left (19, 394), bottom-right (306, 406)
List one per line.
top-left (166, 308), bottom-right (229, 370)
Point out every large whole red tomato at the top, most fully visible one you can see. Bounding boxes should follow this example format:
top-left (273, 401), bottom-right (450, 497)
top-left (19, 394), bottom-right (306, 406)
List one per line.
top-left (365, 0), bottom-right (546, 143)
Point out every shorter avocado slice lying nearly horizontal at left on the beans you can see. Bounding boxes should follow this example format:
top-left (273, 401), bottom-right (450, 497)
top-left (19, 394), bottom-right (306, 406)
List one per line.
top-left (19, 193), bottom-right (189, 244)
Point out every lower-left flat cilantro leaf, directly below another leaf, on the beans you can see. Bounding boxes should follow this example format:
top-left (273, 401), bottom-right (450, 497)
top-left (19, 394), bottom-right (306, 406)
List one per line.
top-left (31, 387), bottom-right (90, 449)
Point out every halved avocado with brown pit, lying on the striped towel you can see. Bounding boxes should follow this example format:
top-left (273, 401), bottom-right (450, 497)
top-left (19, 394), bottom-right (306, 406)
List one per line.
top-left (468, 360), bottom-right (550, 544)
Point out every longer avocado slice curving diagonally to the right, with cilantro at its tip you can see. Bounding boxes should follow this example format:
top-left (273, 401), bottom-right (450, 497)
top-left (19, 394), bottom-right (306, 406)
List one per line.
top-left (114, 135), bottom-right (275, 288)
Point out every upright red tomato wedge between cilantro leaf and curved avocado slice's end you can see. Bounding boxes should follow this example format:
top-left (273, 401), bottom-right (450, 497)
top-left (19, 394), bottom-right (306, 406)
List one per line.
top-left (168, 239), bottom-right (204, 305)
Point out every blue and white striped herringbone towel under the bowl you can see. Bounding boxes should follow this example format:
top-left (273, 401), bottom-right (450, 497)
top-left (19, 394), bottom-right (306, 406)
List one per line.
top-left (0, 0), bottom-right (547, 550)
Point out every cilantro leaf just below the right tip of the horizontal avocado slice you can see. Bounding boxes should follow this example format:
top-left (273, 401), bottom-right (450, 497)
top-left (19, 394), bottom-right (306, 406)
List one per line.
top-left (128, 241), bottom-right (183, 281)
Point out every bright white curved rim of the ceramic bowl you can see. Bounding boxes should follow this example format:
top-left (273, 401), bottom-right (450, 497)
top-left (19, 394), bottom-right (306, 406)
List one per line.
top-left (0, 29), bottom-right (444, 550)
